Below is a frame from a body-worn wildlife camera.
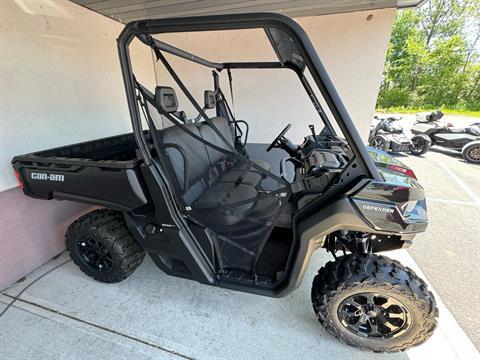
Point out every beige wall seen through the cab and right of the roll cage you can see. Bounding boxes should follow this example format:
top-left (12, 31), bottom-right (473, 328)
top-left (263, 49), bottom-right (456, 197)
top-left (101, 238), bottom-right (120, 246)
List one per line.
top-left (151, 9), bottom-right (394, 143)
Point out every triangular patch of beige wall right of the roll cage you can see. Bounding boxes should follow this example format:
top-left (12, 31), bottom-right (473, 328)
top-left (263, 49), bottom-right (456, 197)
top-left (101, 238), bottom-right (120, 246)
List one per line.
top-left (299, 9), bottom-right (395, 140)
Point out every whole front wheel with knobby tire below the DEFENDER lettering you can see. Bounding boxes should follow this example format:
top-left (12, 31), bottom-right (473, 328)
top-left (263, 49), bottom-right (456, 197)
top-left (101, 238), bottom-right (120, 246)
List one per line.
top-left (312, 255), bottom-right (438, 352)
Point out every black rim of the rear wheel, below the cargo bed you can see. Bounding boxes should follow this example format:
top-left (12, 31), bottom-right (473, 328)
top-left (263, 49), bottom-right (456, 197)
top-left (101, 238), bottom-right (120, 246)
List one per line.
top-left (77, 237), bottom-right (113, 272)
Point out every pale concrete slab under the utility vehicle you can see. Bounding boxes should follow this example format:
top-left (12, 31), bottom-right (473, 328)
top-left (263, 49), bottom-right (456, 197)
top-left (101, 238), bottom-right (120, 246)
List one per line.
top-left (0, 251), bottom-right (478, 360)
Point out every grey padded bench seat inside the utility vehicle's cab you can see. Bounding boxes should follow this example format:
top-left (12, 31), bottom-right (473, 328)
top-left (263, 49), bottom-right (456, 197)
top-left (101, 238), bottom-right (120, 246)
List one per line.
top-left (160, 112), bottom-right (270, 208)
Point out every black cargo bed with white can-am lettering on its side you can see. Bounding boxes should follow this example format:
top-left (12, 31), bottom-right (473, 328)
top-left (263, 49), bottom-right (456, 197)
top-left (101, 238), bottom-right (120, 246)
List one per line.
top-left (12, 133), bottom-right (147, 211)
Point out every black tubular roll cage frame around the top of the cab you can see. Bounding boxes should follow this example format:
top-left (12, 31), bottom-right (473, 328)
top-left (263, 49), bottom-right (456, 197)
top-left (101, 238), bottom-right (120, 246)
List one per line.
top-left (117, 13), bottom-right (380, 179)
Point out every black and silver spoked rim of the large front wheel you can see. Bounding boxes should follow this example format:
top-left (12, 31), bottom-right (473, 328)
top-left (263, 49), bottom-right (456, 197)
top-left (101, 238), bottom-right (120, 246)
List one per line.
top-left (338, 292), bottom-right (410, 339)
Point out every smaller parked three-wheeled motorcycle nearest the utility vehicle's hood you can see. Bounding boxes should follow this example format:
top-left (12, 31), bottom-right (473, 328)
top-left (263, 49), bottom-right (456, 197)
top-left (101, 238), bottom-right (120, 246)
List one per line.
top-left (368, 116), bottom-right (432, 155)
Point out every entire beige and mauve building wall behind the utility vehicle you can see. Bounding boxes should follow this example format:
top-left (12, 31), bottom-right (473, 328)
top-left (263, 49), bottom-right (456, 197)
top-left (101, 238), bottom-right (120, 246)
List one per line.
top-left (0, 0), bottom-right (394, 289)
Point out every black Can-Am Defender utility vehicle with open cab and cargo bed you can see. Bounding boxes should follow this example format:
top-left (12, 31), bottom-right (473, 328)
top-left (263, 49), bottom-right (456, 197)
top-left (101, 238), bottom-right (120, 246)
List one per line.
top-left (12, 13), bottom-right (438, 352)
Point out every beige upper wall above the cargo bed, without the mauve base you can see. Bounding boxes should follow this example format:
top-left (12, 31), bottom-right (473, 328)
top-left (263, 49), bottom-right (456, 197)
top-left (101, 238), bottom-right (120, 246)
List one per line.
top-left (0, 0), bottom-right (153, 191)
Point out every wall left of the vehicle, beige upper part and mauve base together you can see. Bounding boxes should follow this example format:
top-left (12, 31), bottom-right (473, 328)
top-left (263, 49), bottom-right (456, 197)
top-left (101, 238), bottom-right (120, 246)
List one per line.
top-left (0, 0), bottom-right (153, 289)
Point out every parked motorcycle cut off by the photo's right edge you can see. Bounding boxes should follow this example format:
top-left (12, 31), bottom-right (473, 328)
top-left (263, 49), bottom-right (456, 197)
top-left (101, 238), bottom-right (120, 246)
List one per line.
top-left (411, 110), bottom-right (480, 164)
